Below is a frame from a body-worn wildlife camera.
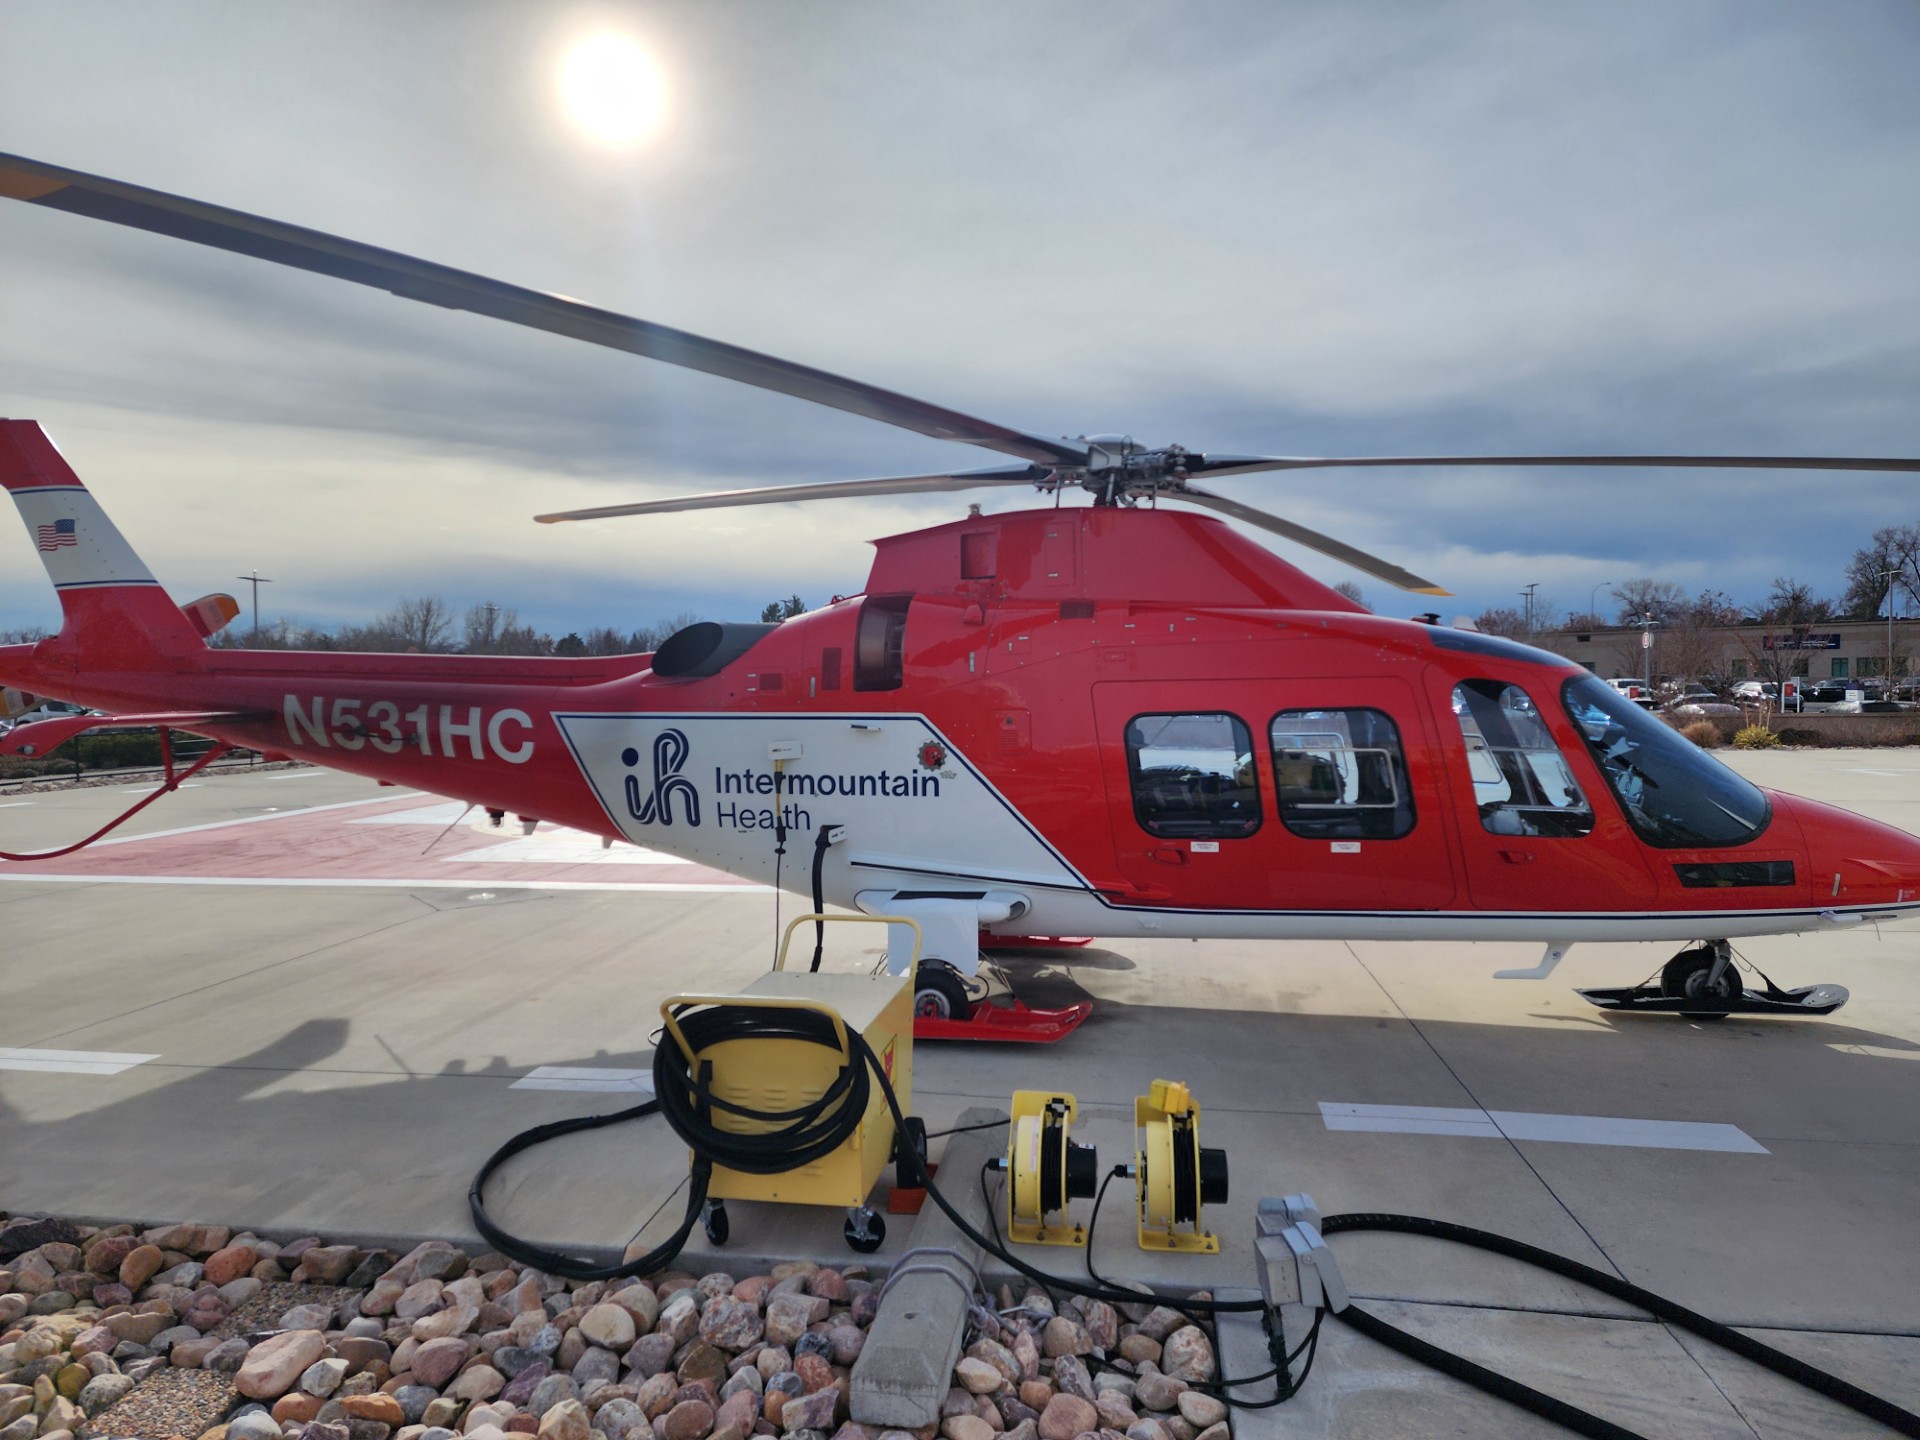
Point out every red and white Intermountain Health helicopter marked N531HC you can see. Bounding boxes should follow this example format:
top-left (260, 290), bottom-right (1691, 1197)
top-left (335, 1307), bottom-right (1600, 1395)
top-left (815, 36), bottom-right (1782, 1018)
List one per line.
top-left (0, 156), bottom-right (1920, 1021)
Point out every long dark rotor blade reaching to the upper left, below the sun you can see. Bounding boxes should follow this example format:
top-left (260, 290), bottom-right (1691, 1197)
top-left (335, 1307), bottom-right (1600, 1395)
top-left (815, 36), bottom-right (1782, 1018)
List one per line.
top-left (0, 154), bottom-right (1087, 465)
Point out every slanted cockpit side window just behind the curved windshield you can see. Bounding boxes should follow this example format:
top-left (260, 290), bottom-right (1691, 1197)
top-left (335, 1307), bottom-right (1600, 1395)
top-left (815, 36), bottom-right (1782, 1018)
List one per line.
top-left (1453, 678), bottom-right (1597, 837)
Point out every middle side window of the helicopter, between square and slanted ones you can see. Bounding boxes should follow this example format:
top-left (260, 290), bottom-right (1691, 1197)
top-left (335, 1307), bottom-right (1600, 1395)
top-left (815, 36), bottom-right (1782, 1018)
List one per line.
top-left (1269, 710), bottom-right (1413, 839)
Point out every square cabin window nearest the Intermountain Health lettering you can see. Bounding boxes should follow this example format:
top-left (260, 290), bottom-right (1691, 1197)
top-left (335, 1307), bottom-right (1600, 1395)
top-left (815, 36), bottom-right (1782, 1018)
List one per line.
top-left (1127, 712), bottom-right (1260, 839)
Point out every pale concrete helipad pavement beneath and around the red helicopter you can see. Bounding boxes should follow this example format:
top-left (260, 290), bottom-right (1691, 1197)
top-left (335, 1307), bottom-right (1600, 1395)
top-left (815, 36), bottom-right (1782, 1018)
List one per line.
top-left (0, 751), bottom-right (1920, 1436)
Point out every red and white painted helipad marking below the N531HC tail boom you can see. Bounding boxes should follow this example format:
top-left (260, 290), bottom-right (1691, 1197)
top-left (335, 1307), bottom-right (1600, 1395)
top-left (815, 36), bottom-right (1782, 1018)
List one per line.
top-left (0, 795), bottom-right (764, 893)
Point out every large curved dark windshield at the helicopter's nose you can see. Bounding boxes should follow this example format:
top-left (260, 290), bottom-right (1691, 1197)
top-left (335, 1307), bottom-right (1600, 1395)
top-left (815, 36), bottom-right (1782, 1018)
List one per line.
top-left (1561, 676), bottom-right (1772, 851)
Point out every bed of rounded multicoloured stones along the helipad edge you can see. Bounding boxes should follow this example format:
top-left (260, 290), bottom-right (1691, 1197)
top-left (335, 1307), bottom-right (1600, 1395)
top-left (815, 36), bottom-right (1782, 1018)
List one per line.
top-left (0, 1217), bottom-right (1227, 1440)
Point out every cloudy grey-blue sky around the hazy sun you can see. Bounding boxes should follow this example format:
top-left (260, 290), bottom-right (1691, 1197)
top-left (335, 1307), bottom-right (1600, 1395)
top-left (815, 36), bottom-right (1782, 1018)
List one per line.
top-left (0, 0), bottom-right (1920, 632)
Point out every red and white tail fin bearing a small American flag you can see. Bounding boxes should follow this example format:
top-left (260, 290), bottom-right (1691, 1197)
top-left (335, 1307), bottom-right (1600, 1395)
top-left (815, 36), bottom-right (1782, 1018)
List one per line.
top-left (0, 420), bottom-right (205, 668)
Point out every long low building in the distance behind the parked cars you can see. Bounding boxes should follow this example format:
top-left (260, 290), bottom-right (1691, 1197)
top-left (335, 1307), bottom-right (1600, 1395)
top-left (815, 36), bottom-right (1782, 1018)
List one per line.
top-left (1532, 618), bottom-right (1920, 687)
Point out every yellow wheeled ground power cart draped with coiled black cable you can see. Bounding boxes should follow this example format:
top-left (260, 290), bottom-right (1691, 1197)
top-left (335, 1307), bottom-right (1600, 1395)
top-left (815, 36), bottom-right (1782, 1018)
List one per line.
top-left (660, 916), bottom-right (920, 1252)
